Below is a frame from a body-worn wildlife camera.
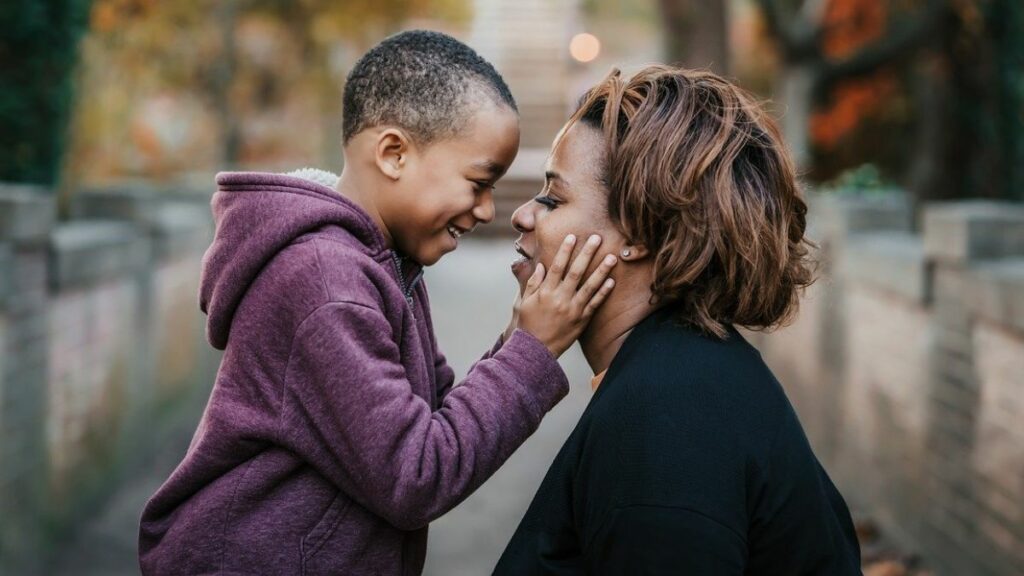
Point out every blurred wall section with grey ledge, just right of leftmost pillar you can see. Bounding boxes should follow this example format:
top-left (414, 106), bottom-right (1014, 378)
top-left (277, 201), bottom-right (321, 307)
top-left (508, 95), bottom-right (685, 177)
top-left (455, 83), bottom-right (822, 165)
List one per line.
top-left (47, 220), bottom-right (153, 516)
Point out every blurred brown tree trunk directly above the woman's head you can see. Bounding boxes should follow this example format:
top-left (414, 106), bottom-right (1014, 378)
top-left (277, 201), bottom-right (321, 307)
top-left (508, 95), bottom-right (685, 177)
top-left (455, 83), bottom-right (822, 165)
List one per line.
top-left (658, 0), bottom-right (729, 75)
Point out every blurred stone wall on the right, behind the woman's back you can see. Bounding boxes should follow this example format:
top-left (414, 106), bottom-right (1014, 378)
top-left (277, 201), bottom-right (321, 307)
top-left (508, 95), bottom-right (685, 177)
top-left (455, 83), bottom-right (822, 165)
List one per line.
top-left (751, 193), bottom-right (1024, 575)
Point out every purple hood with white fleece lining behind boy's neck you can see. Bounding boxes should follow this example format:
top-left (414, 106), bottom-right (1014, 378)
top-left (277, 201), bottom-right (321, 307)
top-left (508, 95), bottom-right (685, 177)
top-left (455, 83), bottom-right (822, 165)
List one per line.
top-left (200, 168), bottom-right (387, 349)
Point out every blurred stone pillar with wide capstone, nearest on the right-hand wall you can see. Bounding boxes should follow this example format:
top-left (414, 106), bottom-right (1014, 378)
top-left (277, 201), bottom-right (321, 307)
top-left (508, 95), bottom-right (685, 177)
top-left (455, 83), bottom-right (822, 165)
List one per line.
top-left (922, 201), bottom-right (1024, 574)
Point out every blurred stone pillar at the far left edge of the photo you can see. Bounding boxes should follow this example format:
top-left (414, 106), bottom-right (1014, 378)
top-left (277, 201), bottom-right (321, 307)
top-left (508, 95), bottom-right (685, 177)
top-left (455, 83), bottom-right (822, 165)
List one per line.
top-left (0, 184), bottom-right (56, 574)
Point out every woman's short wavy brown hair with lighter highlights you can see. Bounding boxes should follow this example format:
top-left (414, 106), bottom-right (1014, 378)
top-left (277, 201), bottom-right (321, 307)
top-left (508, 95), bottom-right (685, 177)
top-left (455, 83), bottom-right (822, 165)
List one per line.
top-left (569, 66), bottom-right (813, 337)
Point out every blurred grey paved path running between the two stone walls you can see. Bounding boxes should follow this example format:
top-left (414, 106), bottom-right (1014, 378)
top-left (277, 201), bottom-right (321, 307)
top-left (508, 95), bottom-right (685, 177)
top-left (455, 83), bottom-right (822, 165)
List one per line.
top-left (47, 240), bottom-right (591, 576)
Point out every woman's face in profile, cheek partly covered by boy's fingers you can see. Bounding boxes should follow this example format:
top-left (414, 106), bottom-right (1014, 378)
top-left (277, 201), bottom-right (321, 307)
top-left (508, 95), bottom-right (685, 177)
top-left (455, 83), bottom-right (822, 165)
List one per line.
top-left (512, 123), bottom-right (625, 290)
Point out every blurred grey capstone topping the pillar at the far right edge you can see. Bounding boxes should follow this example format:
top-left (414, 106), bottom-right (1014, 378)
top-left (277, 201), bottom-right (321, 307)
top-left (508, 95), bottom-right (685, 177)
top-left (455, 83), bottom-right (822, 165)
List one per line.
top-left (924, 200), bottom-right (1024, 264)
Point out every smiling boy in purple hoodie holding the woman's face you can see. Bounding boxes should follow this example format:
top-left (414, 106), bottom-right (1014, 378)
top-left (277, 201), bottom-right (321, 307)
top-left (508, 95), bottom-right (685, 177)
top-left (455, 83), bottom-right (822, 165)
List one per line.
top-left (139, 32), bottom-right (614, 574)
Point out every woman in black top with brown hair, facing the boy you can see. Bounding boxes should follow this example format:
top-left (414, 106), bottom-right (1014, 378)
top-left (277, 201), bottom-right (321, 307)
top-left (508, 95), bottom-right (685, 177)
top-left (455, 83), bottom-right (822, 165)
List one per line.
top-left (496, 67), bottom-right (860, 576)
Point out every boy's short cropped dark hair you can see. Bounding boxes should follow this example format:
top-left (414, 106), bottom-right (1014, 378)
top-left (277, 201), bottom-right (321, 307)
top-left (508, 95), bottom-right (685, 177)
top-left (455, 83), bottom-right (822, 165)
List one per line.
top-left (342, 30), bottom-right (518, 145)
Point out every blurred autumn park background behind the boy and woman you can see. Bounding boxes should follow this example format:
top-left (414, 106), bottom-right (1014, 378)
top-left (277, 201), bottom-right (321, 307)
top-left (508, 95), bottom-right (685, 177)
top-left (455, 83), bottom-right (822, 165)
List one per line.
top-left (0, 0), bottom-right (1024, 576)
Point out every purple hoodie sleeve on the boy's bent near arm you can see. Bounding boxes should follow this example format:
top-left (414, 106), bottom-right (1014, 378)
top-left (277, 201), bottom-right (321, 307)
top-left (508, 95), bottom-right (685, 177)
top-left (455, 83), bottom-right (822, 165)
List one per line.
top-left (281, 302), bottom-right (568, 530)
